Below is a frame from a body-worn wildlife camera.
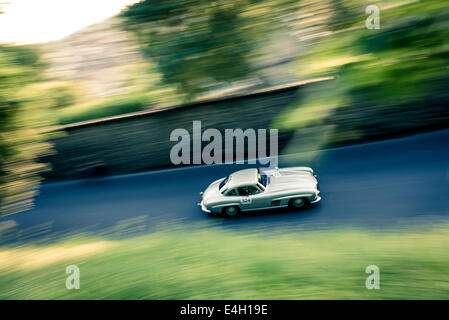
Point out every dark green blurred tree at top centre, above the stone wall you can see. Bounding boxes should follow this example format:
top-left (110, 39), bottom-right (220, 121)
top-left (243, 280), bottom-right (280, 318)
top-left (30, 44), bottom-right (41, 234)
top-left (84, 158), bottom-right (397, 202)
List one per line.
top-left (123, 0), bottom-right (296, 100)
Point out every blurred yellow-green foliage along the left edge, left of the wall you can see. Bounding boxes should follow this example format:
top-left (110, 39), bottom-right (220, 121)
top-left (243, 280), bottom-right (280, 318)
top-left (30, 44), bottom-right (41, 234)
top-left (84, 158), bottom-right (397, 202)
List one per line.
top-left (0, 45), bottom-right (55, 214)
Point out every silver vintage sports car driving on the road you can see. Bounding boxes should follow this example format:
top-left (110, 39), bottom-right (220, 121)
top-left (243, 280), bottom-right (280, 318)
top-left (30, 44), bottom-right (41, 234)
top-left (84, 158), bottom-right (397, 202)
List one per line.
top-left (199, 167), bottom-right (321, 216)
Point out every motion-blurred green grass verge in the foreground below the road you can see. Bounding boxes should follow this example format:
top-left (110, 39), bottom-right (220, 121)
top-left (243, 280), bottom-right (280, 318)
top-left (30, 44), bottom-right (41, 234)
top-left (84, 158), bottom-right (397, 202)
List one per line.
top-left (0, 225), bottom-right (449, 299)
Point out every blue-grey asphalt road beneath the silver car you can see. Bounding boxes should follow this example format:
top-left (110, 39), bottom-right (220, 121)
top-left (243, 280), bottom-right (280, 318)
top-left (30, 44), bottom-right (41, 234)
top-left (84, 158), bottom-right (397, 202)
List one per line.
top-left (0, 130), bottom-right (449, 240)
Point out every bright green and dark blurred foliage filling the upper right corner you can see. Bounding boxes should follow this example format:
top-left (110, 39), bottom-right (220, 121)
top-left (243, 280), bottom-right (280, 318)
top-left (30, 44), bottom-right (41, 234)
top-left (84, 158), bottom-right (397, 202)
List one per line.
top-left (280, 0), bottom-right (449, 143)
